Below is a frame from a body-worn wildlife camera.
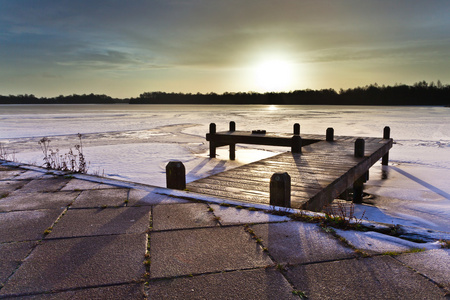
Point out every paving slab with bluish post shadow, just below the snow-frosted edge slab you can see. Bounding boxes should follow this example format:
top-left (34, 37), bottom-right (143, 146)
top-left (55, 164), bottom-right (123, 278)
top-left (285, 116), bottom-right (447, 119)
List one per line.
top-left (251, 222), bottom-right (356, 264)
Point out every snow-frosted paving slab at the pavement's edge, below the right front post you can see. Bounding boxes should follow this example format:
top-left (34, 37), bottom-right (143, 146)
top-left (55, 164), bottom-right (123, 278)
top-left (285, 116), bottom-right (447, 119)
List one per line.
top-left (210, 204), bottom-right (291, 225)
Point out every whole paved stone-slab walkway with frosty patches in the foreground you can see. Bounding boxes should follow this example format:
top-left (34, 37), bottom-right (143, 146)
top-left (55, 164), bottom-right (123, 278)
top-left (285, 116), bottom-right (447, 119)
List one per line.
top-left (0, 162), bottom-right (450, 299)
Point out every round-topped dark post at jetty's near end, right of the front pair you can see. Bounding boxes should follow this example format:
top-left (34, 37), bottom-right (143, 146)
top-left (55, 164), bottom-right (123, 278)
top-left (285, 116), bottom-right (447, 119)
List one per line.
top-left (270, 172), bottom-right (291, 207)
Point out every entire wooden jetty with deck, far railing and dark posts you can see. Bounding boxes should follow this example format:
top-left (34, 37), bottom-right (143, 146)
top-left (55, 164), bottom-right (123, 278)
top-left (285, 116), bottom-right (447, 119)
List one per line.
top-left (167, 122), bottom-right (393, 211)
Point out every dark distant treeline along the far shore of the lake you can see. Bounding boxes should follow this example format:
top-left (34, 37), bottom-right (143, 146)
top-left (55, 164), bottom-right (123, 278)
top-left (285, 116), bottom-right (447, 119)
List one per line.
top-left (0, 81), bottom-right (450, 106)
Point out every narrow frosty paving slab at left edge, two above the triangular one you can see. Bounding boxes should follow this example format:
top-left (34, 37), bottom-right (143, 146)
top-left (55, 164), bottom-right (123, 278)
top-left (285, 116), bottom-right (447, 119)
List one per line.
top-left (0, 192), bottom-right (80, 211)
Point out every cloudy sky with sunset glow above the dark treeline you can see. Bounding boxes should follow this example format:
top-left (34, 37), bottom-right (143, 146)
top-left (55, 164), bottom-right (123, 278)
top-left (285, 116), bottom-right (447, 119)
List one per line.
top-left (0, 0), bottom-right (450, 98)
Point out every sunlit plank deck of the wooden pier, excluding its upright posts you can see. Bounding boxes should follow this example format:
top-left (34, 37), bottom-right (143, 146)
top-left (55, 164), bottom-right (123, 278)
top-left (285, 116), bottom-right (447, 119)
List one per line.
top-left (187, 131), bottom-right (393, 211)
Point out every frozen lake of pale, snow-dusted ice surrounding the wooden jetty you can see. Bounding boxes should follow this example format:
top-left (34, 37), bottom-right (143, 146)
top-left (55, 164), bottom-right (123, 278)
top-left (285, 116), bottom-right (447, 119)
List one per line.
top-left (0, 104), bottom-right (450, 232)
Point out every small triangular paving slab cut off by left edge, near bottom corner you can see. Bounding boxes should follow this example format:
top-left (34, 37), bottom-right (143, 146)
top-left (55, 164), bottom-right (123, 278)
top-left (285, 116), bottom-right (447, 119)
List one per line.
top-left (0, 242), bottom-right (36, 287)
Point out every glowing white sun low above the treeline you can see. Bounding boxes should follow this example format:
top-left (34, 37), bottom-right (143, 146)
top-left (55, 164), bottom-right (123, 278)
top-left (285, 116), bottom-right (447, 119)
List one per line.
top-left (254, 59), bottom-right (293, 92)
